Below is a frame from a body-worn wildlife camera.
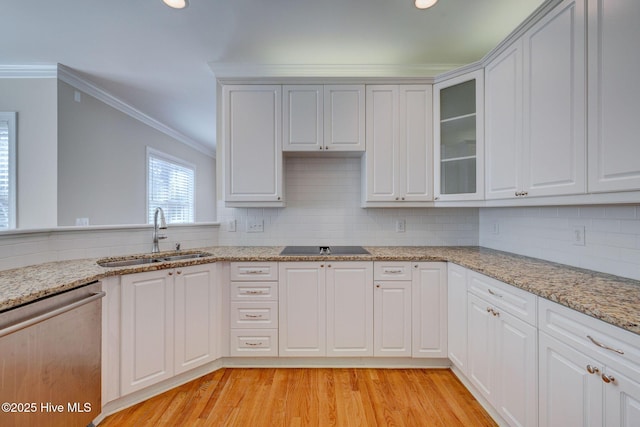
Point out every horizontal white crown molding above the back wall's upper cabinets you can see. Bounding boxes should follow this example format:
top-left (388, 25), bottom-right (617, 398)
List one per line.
top-left (209, 62), bottom-right (461, 81)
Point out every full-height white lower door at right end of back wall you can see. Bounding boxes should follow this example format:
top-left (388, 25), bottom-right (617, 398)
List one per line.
top-left (411, 262), bottom-right (447, 357)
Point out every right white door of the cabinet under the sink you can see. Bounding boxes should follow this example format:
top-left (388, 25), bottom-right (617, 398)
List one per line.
top-left (174, 264), bottom-right (220, 374)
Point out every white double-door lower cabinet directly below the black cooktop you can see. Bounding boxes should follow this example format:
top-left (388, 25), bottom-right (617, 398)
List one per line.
top-left (279, 261), bottom-right (373, 357)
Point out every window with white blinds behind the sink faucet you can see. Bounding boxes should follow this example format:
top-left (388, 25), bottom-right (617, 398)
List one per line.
top-left (147, 148), bottom-right (196, 224)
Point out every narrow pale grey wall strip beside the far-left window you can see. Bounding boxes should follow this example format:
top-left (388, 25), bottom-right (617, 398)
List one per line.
top-left (0, 78), bottom-right (58, 229)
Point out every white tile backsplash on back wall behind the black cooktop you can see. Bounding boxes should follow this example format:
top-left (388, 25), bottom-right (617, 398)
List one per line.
top-left (218, 157), bottom-right (478, 246)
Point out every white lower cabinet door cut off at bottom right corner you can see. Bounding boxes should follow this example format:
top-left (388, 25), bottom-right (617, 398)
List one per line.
top-left (602, 368), bottom-right (640, 427)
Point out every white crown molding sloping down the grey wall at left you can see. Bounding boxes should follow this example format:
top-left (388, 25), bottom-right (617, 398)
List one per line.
top-left (56, 64), bottom-right (216, 158)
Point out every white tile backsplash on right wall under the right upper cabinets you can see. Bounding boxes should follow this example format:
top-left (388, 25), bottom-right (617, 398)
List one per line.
top-left (480, 205), bottom-right (640, 280)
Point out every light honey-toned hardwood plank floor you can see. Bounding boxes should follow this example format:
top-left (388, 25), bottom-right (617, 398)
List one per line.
top-left (100, 368), bottom-right (496, 427)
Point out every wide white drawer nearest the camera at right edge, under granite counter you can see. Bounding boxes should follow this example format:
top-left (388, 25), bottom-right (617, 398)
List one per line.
top-left (538, 298), bottom-right (640, 375)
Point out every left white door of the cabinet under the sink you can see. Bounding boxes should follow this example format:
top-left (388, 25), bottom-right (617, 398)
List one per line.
top-left (120, 270), bottom-right (174, 395)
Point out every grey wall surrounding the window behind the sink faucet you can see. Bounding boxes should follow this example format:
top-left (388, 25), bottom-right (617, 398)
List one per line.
top-left (57, 81), bottom-right (216, 226)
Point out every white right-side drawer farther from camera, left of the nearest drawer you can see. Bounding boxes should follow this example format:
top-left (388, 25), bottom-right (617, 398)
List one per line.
top-left (467, 271), bottom-right (538, 326)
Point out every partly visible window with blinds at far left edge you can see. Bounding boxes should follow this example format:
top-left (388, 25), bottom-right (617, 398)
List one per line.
top-left (0, 112), bottom-right (16, 230)
